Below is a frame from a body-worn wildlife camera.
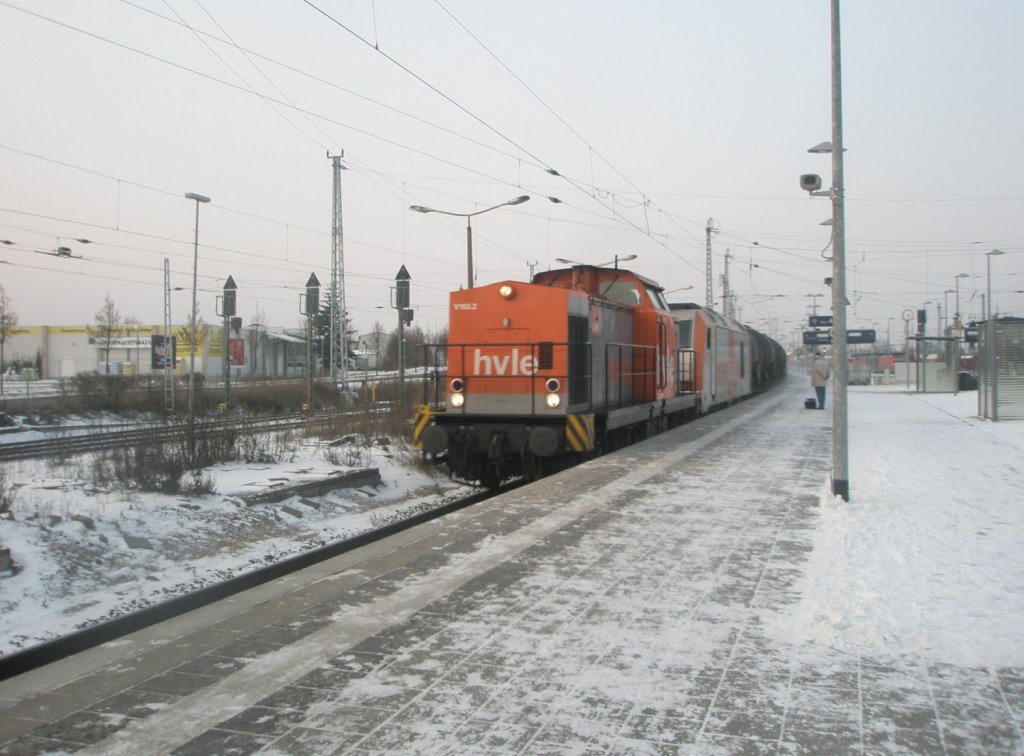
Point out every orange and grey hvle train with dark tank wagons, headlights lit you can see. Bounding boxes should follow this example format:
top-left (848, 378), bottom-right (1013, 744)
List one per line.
top-left (413, 265), bottom-right (786, 486)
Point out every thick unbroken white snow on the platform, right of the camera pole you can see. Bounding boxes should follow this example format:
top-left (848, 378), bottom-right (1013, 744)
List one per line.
top-left (772, 386), bottom-right (1024, 667)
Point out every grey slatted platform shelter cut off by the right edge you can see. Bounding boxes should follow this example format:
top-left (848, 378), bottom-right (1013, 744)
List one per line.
top-left (978, 320), bottom-right (1024, 420)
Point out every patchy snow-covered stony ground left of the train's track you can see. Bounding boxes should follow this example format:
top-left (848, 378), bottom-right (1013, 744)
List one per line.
top-left (0, 430), bottom-right (468, 654)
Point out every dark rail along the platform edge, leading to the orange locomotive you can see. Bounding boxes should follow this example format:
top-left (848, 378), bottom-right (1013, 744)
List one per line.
top-left (0, 480), bottom-right (516, 680)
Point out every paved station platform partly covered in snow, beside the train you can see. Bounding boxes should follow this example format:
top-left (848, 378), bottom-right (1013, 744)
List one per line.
top-left (0, 377), bottom-right (1024, 754)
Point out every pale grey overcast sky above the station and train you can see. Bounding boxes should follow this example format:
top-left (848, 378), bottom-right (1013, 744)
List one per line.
top-left (0, 0), bottom-right (1024, 341)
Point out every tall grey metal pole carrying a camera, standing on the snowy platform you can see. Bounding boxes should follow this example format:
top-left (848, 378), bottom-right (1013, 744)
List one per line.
top-left (831, 0), bottom-right (850, 501)
